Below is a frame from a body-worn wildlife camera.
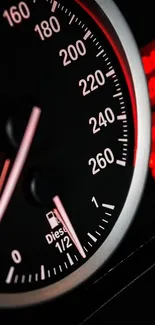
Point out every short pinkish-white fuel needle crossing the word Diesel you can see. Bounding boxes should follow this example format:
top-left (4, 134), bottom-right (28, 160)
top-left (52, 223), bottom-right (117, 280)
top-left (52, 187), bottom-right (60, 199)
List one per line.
top-left (53, 196), bottom-right (86, 258)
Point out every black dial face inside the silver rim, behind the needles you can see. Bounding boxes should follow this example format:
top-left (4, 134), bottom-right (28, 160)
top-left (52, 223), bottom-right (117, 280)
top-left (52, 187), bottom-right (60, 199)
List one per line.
top-left (0, 0), bottom-right (136, 293)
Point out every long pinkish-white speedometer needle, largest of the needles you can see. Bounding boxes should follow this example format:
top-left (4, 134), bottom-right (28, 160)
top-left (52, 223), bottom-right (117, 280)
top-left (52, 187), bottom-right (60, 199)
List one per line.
top-left (0, 107), bottom-right (41, 221)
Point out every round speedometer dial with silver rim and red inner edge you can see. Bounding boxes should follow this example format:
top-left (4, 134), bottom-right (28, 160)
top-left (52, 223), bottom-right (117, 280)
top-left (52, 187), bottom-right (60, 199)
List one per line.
top-left (0, 0), bottom-right (150, 306)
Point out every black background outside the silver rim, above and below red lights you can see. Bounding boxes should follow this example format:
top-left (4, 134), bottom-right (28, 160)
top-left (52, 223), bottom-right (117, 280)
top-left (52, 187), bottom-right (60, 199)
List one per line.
top-left (0, 0), bottom-right (155, 325)
